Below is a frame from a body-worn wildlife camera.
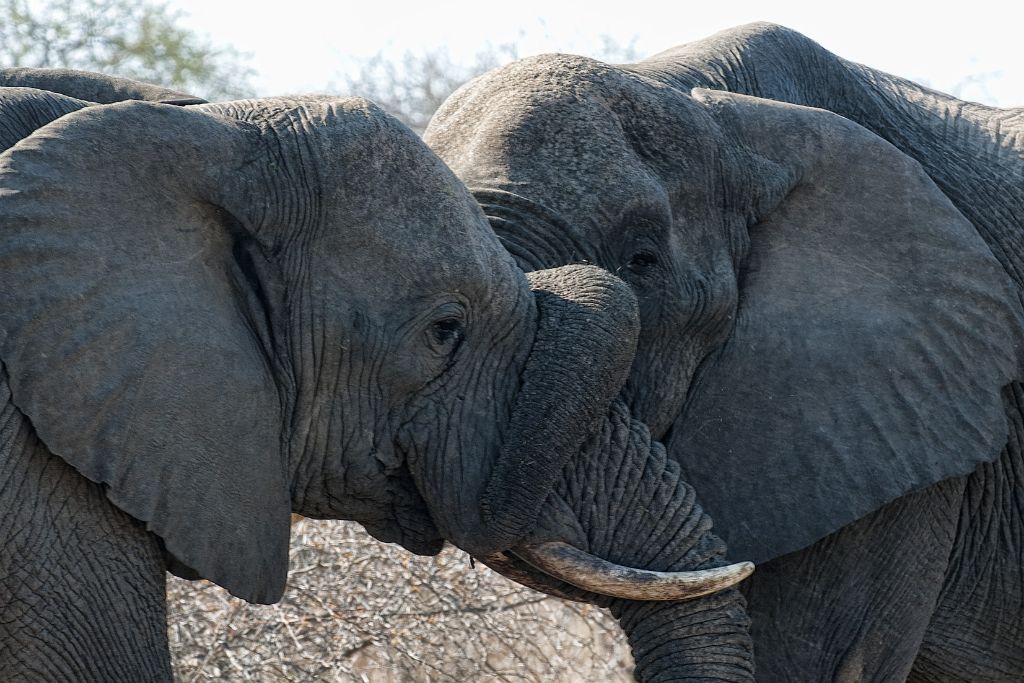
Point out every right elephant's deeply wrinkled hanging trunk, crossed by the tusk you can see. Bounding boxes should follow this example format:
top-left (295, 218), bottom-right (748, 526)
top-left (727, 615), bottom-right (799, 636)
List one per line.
top-left (481, 399), bottom-right (754, 683)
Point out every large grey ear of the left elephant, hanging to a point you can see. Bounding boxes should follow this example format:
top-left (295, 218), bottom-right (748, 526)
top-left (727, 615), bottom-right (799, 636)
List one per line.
top-left (0, 102), bottom-right (291, 602)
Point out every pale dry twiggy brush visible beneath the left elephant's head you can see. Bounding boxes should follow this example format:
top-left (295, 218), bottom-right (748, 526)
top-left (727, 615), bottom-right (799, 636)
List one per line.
top-left (168, 520), bottom-right (632, 683)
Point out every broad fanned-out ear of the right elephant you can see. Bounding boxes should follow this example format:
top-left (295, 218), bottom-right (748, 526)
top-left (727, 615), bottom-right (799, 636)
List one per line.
top-left (670, 91), bottom-right (1024, 561)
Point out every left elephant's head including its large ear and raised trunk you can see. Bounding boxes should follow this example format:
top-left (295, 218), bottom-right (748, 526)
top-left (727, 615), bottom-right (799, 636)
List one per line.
top-left (0, 91), bottom-right (635, 602)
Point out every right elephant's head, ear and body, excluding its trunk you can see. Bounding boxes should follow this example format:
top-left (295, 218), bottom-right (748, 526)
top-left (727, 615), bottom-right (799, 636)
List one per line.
top-left (424, 24), bottom-right (1024, 681)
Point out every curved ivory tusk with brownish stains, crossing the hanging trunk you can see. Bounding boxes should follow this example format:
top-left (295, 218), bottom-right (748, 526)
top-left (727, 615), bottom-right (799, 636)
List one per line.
top-left (479, 542), bottom-right (754, 601)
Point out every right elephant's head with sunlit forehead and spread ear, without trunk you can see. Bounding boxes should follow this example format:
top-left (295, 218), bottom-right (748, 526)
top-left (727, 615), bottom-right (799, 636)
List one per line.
top-left (425, 50), bottom-right (1024, 577)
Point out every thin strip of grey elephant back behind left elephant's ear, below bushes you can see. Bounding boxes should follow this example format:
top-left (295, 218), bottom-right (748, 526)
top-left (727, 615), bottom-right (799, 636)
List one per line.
top-left (0, 67), bottom-right (206, 104)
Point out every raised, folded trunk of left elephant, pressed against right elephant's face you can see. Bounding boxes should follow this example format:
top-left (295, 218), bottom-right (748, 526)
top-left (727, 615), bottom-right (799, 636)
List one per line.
top-left (481, 266), bottom-right (639, 551)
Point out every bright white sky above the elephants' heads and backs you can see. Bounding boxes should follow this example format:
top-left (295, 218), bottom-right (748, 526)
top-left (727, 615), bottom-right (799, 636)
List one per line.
top-left (170, 0), bottom-right (1024, 106)
